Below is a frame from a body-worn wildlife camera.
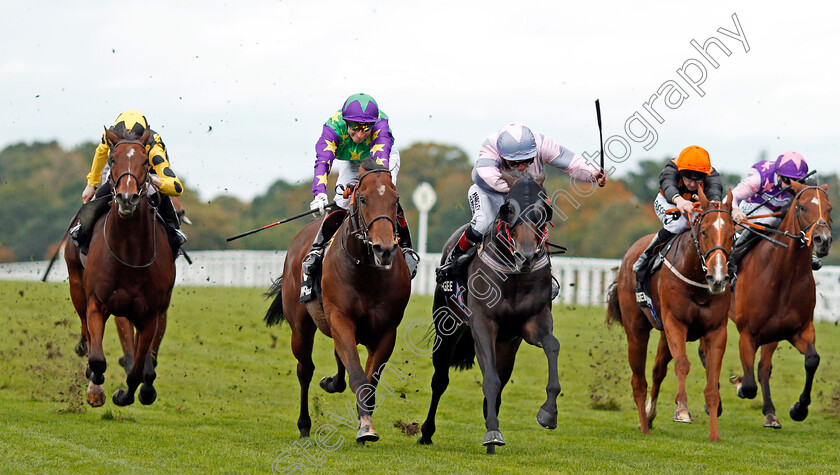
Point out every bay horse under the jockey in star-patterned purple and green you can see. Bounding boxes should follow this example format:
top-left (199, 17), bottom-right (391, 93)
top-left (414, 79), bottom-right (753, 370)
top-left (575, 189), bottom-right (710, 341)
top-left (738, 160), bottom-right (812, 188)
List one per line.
top-left (264, 159), bottom-right (411, 443)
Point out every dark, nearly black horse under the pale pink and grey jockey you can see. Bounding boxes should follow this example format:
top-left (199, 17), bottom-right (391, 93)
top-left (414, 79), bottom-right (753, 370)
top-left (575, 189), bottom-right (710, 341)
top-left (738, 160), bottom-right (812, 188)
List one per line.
top-left (418, 173), bottom-right (560, 454)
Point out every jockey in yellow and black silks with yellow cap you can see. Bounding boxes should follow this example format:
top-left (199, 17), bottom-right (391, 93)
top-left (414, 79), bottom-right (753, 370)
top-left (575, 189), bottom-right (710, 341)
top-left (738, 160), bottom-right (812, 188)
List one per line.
top-left (70, 110), bottom-right (187, 257)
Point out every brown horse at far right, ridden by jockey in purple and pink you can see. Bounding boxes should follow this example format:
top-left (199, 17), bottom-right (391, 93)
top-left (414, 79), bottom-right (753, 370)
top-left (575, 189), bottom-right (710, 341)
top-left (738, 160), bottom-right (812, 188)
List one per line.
top-left (729, 182), bottom-right (831, 429)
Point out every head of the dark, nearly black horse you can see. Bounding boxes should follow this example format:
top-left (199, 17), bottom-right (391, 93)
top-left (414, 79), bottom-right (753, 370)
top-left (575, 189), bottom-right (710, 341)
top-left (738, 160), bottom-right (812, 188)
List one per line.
top-left (493, 172), bottom-right (552, 272)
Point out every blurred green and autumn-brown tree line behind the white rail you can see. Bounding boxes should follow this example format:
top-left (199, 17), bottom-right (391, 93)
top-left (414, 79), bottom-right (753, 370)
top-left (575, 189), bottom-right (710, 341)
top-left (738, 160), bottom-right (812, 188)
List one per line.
top-left (0, 142), bottom-right (840, 264)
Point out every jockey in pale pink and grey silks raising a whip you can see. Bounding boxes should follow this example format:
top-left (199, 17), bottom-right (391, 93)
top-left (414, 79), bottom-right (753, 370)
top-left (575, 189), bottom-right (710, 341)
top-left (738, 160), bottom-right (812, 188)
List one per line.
top-left (435, 123), bottom-right (607, 300)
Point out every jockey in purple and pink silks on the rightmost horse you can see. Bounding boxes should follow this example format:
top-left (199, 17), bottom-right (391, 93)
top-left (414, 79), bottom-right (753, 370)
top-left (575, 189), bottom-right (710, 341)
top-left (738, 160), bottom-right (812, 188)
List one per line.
top-left (732, 151), bottom-right (822, 270)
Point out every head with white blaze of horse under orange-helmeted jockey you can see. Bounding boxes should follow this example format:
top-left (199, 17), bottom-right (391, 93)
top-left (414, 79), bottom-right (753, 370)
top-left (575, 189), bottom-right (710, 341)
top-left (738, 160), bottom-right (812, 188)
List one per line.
top-left (696, 188), bottom-right (735, 294)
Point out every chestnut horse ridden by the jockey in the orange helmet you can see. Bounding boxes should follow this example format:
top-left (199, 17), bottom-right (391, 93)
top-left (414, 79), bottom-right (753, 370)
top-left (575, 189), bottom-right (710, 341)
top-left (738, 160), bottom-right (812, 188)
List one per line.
top-left (607, 189), bottom-right (735, 441)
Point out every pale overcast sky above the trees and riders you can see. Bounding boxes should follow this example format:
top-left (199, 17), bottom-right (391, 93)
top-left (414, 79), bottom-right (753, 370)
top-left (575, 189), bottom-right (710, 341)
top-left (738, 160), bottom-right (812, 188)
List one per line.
top-left (0, 0), bottom-right (840, 199)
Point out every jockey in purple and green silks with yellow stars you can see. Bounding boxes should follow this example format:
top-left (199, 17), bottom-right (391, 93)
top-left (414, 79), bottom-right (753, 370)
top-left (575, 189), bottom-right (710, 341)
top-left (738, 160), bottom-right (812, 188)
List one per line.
top-left (300, 93), bottom-right (420, 302)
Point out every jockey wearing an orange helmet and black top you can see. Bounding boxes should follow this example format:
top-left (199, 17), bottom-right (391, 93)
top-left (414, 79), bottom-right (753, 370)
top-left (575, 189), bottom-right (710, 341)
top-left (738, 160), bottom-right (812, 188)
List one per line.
top-left (633, 145), bottom-right (731, 307)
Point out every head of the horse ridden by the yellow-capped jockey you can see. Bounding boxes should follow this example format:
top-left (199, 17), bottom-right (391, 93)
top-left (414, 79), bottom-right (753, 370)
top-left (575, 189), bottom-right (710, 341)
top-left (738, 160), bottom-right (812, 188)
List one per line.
top-left (105, 129), bottom-right (151, 218)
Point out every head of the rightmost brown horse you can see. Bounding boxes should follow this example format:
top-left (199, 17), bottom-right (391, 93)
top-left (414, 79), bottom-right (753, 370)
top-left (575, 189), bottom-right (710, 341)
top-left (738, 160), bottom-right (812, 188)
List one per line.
top-left (791, 181), bottom-right (831, 257)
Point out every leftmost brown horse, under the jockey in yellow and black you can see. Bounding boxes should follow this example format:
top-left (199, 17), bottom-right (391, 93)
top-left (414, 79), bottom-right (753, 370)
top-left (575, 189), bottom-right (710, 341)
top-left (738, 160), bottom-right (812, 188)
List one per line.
top-left (65, 130), bottom-right (175, 406)
